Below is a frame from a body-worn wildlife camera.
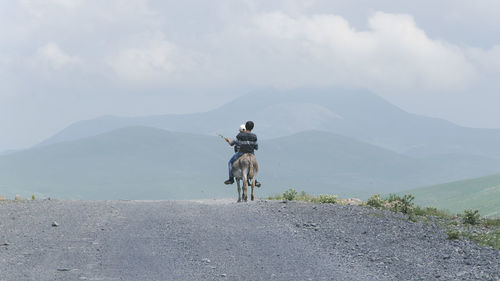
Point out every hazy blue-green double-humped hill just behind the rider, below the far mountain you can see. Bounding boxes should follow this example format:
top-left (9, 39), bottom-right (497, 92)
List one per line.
top-left (0, 127), bottom-right (500, 199)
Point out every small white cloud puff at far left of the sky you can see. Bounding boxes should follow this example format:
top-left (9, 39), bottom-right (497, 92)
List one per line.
top-left (36, 42), bottom-right (81, 70)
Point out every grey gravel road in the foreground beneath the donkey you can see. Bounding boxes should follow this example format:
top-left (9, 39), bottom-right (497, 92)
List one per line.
top-left (0, 199), bottom-right (500, 281)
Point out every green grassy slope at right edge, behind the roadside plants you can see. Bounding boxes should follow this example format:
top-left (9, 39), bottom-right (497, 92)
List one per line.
top-left (405, 174), bottom-right (500, 218)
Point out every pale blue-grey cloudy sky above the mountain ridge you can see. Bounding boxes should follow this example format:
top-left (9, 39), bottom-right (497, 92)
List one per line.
top-left (0, 0), bottom-right (500, 151)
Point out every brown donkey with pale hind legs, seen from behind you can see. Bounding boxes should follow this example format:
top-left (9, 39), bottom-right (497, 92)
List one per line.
top-left (233, 153), bottom-right (259, 202)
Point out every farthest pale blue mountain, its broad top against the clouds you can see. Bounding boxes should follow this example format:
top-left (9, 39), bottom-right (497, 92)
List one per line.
top-left (41, 88), bottom-right (500, 158)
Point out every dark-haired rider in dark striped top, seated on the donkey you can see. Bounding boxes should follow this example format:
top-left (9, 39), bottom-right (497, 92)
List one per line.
top-left (224, 121), bottom-right (260, 187)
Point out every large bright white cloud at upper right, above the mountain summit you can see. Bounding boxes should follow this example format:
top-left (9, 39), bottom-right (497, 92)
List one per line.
top-left (255, 12), bottom-right (477, 91)
